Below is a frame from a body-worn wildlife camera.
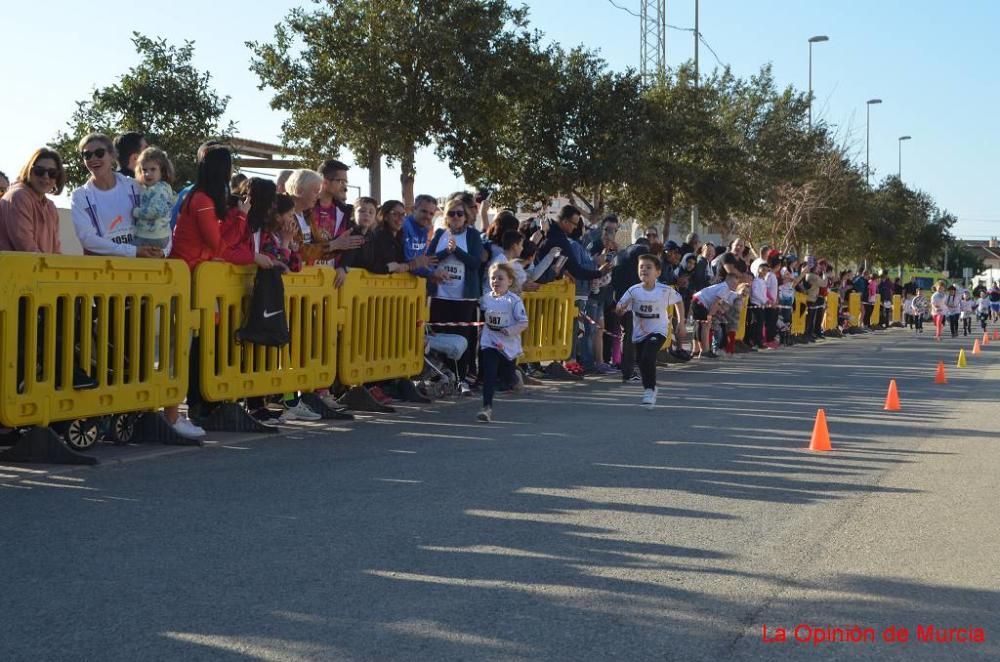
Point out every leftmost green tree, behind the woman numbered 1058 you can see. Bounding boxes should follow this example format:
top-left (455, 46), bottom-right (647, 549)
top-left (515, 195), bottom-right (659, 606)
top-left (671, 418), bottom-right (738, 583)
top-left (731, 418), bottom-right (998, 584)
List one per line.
top-left (50, 32), bottom-right (236, 188)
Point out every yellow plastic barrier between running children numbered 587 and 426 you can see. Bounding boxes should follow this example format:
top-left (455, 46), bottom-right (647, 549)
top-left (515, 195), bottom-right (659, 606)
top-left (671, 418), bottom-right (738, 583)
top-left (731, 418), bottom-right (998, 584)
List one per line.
top-left (519, 278), bottom-right (576, 363)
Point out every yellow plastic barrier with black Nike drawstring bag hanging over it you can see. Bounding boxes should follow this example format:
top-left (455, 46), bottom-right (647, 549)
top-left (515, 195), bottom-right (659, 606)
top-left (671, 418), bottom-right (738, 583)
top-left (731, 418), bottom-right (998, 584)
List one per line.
top-left (193, 262), bottom-right (341, 402)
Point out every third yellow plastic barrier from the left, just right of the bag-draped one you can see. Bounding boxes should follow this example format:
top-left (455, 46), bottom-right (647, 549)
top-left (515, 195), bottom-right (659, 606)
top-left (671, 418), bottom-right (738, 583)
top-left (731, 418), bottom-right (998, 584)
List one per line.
top-left (337, 269), bottom-right (429, 386)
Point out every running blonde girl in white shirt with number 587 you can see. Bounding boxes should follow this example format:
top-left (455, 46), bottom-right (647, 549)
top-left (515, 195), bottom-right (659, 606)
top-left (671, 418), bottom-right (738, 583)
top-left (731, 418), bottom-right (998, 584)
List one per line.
top-left (476, 262), bottom-right (528, 423)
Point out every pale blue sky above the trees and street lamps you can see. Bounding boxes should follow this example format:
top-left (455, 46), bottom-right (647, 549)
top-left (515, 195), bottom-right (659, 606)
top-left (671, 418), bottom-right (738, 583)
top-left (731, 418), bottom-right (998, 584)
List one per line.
top-left (0, 0), bottom-right (1000, 238)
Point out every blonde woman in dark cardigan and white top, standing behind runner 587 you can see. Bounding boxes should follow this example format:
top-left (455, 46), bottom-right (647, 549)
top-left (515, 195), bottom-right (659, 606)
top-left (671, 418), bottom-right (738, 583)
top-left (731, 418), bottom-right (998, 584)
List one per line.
top-left (427, 198), bottom-right (483, 394)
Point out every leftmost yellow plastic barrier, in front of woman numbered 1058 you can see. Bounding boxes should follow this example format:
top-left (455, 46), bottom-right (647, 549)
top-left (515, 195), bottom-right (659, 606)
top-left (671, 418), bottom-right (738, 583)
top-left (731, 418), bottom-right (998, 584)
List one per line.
top-left (0, 253), bottom-right (191, 427)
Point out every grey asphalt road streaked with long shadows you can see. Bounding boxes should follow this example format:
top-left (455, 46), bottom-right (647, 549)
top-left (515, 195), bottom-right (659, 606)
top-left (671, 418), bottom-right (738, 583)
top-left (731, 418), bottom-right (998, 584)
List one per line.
top-left (0, 331), bottom-right (1000, 662)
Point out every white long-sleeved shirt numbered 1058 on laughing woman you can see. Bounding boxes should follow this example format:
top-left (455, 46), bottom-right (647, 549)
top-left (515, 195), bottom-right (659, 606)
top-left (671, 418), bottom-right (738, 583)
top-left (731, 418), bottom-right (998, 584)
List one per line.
top-left (70, 172), bottom-right (143, 257)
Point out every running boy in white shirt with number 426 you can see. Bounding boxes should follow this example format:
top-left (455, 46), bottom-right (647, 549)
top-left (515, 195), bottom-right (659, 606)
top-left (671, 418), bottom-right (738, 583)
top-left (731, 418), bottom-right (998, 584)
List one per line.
top-left (615, 255), bottom-right (685, 409)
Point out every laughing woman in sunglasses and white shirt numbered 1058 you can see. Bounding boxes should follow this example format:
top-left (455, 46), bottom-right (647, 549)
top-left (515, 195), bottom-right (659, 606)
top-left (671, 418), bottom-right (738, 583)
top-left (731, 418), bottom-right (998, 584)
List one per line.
top-left (70, 133), bottom-right (161, 257)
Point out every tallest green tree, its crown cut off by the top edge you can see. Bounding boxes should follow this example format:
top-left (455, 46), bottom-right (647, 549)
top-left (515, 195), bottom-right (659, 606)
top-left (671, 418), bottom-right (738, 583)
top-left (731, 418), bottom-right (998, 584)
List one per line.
top-left (247, 0), bottom-right (534, 205)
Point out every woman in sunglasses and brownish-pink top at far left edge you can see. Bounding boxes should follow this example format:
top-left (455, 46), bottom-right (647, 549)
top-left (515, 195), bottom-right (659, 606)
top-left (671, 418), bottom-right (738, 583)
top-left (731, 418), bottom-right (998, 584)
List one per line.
top-left (0, 147), bottom-right (66, 253)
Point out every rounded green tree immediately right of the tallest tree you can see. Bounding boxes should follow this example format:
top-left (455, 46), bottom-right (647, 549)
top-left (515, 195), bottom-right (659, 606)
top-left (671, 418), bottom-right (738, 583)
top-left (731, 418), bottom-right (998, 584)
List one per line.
top-left (458, 46), bottom-right (641, 219)
